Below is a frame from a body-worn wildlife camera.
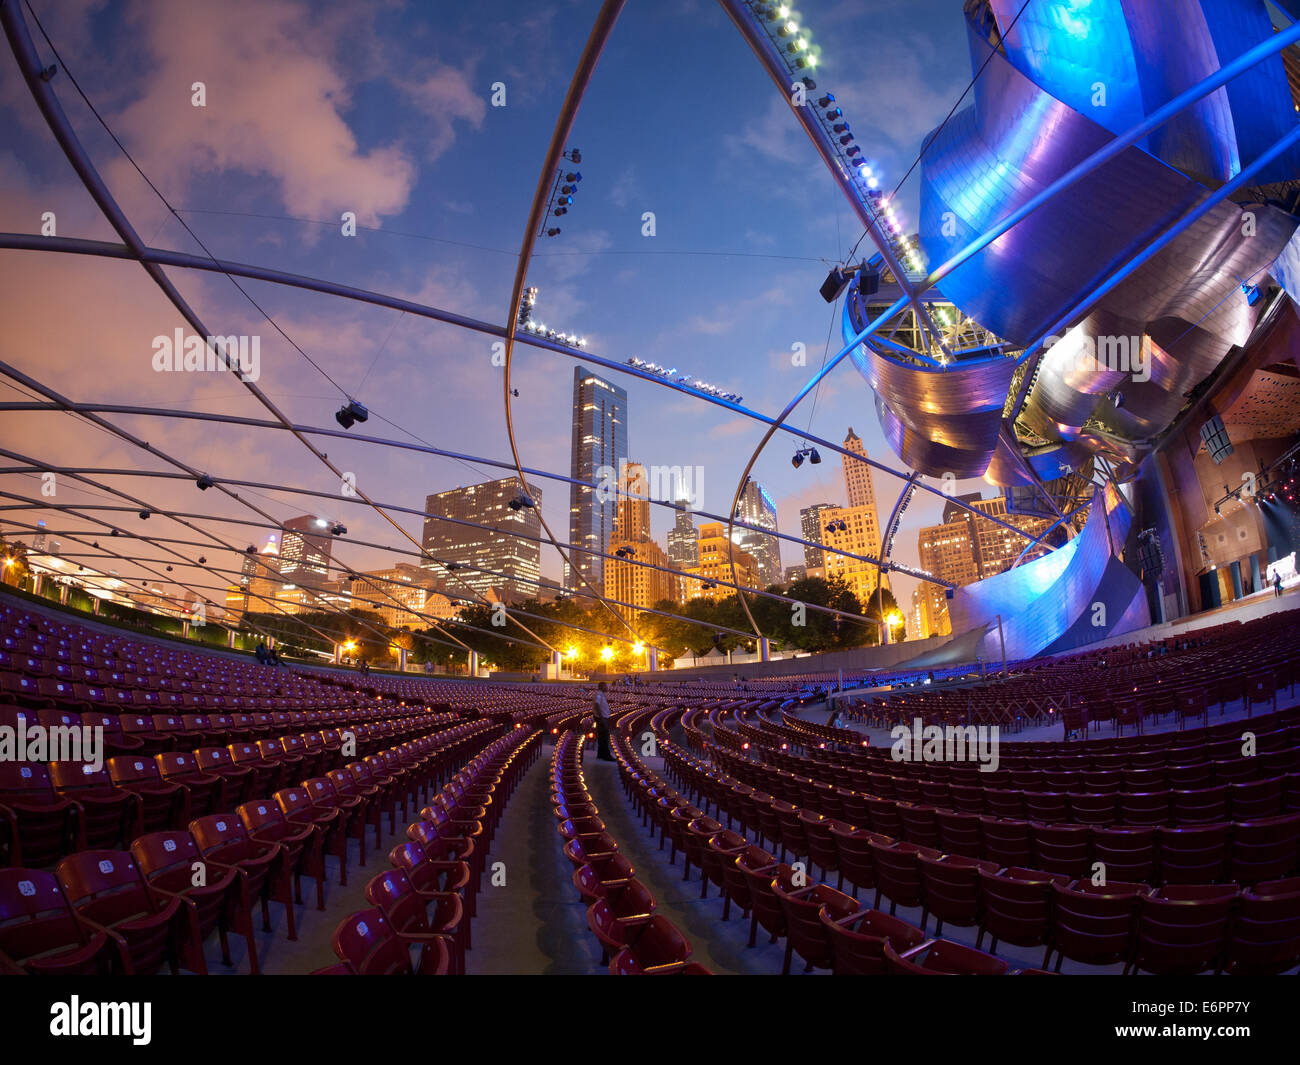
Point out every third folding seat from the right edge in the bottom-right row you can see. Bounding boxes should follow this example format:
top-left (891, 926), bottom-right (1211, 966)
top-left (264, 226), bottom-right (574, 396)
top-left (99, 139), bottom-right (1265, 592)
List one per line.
top-left (1043, 880), bottom-right (1151, 973)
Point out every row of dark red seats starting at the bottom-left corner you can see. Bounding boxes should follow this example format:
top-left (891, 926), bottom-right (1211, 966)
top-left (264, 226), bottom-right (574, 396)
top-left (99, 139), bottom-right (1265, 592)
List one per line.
top-left (0, 724), bottom-right (490, 975)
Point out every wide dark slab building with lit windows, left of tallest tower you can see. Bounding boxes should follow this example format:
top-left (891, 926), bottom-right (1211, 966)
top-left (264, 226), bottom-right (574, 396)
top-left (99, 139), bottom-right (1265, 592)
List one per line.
top-left (421, 477), bottom-right (542, 602)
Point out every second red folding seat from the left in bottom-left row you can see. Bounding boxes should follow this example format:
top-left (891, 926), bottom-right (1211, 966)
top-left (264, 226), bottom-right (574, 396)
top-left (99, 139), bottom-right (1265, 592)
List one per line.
top-left (55, 850), bottom-right (189, 975)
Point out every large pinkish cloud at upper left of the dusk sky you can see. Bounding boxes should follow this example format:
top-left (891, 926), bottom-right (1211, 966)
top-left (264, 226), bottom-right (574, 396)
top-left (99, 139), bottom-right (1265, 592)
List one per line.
top-left (117, 0), bottom-right (418, 225)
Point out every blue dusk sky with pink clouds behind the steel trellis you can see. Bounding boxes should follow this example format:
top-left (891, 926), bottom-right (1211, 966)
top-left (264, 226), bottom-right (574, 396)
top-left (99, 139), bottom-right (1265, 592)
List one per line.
top-left (0, 0), bottom-right (992, 624)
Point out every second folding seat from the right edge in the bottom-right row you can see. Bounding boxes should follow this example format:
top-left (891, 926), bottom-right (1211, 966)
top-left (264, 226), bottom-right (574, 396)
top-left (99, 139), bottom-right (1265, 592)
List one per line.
top-left (1131, 884), bottom-right (1238, 977)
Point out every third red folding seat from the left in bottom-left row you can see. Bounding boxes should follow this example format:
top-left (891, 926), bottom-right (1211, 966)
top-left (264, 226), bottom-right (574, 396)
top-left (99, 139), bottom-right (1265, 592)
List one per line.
top-left (131, 832), bottom-right (248, 974)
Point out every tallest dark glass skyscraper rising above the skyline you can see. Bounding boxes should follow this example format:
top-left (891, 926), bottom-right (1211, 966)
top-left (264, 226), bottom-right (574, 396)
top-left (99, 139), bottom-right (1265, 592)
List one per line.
top-left (564, 367), bottom-right (628, 594)
